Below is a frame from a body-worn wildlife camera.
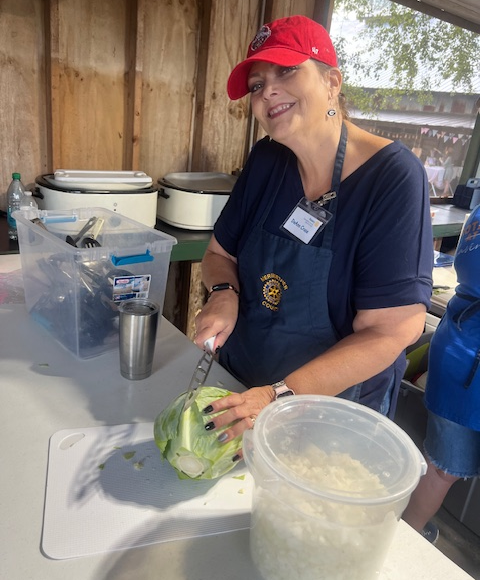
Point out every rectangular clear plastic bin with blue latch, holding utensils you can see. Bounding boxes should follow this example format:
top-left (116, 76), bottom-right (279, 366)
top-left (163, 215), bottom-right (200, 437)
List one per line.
top-left (14, 207), bottom-right (176, 359)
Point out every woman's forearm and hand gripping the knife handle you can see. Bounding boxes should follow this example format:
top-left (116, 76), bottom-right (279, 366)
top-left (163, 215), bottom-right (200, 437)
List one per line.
top-left (195, 236), bottom-right (241, 349)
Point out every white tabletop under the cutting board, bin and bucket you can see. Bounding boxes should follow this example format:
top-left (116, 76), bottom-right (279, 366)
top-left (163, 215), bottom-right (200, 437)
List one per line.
top-left (0, 256), bottom-right (471, 580)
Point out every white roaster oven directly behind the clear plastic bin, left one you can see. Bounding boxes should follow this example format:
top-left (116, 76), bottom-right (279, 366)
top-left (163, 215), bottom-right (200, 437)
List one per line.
top-left (35, 169), bottom-right (158, 228)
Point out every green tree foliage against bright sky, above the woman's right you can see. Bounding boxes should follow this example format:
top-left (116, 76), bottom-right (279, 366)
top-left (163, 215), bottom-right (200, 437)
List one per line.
top-left (334, 0), bottom-right (480, 111)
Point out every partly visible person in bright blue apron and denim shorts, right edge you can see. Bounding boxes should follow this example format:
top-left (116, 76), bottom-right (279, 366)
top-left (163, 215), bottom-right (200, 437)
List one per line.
top-left (403, 205), bottom-right (480, 542)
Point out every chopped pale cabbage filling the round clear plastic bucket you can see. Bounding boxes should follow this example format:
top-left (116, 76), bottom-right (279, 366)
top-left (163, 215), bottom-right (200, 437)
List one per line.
top-left (250, 447), bottom-right (405, 580)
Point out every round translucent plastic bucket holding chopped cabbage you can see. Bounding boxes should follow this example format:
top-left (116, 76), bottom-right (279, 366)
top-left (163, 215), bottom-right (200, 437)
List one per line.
top-left (243, 395), bottom-right (426, 580)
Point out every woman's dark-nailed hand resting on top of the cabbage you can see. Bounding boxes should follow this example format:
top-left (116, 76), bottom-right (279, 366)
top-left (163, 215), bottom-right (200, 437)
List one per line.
top-left (203, 385), bottom-right (274, 461)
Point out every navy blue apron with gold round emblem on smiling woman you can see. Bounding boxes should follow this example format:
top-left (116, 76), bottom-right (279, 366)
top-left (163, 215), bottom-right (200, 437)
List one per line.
top-left (219, 125), bottom-right (361, 401)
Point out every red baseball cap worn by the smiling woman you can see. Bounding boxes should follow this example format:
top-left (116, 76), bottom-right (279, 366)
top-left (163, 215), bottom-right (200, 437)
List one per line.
top-left (227, 16), bottom-right (337, 101)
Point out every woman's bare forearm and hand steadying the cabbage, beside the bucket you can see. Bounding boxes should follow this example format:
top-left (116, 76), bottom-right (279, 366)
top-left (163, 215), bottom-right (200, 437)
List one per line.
top-left (204, 304), bottom-right (426, 441)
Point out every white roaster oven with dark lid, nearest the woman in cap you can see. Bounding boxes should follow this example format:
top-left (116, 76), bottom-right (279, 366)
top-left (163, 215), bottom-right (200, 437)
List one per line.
top-left (157, 172), bottom-right (237, 230)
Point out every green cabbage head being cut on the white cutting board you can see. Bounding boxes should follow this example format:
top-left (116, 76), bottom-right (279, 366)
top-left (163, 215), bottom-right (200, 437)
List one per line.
top-left (154, 387), bottom-right (242, 479)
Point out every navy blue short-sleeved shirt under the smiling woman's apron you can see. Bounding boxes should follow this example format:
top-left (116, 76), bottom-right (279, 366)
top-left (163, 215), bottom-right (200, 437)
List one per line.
top-left (214, 137), bottom-right (433, 410)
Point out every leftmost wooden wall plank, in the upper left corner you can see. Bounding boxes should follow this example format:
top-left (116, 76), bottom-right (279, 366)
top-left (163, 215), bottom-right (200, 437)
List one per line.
top-left (0, 0), bottom-right (47, 198)
